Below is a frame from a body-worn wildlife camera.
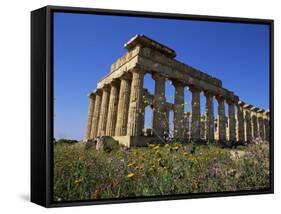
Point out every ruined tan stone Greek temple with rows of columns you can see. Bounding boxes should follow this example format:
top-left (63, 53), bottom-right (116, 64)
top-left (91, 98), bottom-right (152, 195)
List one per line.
top-left (85, 35), bottom-right (270, 147)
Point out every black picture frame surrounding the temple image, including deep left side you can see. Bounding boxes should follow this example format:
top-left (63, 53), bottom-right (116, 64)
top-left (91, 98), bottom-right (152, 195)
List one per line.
top-left (31, 6), bottom-right (274, 207)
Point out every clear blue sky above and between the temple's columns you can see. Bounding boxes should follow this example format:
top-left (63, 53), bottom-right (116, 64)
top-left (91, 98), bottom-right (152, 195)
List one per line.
top-left (54, 13), bottom-right (270, 140)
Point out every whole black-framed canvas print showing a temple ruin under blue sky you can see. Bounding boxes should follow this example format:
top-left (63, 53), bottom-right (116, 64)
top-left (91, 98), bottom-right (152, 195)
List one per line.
top-left (31, 6), bottom-right (274, 207)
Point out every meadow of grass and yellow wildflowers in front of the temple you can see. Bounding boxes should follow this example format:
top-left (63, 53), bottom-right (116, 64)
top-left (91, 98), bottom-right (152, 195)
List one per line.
top-left (54, 143), bottom-right (269, 201)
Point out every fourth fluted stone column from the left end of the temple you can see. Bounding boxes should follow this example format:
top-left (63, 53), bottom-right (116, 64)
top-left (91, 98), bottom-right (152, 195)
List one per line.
top-left (105, 80), bottom-right (119, 136)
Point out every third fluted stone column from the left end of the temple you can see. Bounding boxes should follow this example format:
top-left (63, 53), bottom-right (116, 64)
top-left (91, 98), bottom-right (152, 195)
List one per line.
top-left (98, 85), bottom-right (110, 136)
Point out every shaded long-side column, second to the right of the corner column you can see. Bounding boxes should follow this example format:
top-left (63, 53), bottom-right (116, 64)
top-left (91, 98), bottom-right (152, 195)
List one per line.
top-left (173, 81), bottom-right (184, 138)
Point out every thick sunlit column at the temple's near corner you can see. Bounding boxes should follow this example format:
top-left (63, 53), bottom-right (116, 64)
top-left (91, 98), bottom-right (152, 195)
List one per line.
top-left (127, 68), bottom-right (145, 136)
